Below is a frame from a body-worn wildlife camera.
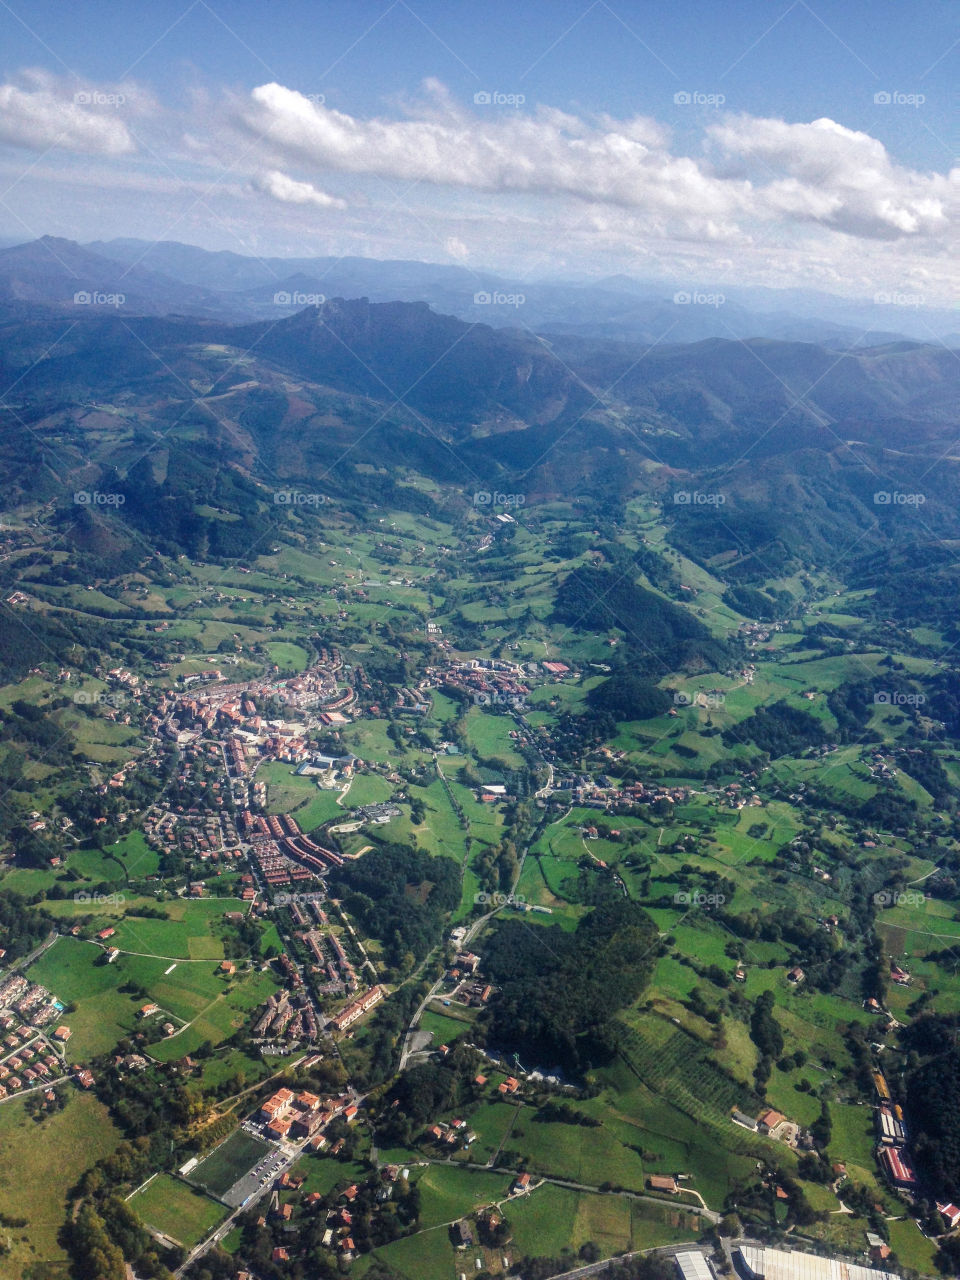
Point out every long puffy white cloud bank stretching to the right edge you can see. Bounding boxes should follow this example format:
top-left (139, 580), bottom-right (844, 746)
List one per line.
top-left (241, 82), bottom-right (960, 249)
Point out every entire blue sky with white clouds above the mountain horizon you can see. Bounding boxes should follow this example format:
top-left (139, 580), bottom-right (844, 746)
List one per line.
top-left (0, 0), bottom-right (960, 307)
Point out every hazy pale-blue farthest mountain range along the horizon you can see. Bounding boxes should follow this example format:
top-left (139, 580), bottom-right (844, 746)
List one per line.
top-left (0, 236), bottom-right (956, 348)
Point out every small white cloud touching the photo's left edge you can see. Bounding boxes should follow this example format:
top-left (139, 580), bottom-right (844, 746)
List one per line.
top-left (0, 73), bottom-right (134, 156)
